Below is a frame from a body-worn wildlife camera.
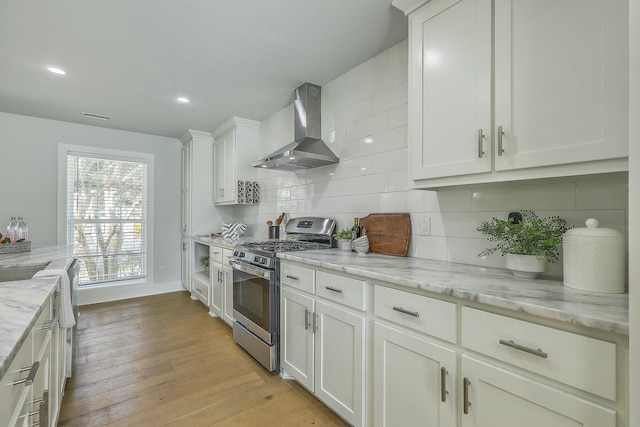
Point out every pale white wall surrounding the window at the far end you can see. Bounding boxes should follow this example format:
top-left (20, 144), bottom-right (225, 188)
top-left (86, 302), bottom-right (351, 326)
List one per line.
top-left (0, 113), bottom-right (181, 302)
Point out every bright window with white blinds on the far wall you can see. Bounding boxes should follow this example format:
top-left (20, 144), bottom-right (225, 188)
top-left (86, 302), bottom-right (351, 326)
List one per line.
top-left (66, 150), bottom-right (149, 285)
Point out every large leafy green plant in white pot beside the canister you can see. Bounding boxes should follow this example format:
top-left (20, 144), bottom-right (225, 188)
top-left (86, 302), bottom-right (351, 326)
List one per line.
top-left (478, 210), bottom-right (571, 278)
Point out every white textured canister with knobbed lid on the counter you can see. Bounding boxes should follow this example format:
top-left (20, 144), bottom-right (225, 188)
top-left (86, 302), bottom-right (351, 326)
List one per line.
top-left (562, 218), bottom-right (625, 294)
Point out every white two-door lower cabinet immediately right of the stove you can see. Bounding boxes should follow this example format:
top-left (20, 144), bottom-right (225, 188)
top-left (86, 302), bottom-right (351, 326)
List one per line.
top-left (280, 266), bottom-right (366, 426)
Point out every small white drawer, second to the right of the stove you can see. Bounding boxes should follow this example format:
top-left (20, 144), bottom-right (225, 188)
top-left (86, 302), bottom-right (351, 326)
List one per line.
top-left (316, 271), bottom-right (367, 311)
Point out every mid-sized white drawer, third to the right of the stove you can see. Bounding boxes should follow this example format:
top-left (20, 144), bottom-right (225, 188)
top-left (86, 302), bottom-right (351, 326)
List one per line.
top-left (374, 285), bottom-right (457, 343)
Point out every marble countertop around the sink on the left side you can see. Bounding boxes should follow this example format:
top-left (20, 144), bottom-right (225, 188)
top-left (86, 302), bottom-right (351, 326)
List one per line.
top-left (0, 246), bottom-right (73, 378)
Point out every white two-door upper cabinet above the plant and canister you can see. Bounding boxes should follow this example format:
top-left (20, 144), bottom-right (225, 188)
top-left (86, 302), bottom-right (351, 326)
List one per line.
top-left (402, 0), bottom-right (628, 188)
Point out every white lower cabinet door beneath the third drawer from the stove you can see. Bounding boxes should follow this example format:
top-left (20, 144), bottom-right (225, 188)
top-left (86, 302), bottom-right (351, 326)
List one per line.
top-left (373, 322), bottom-right (458, 427)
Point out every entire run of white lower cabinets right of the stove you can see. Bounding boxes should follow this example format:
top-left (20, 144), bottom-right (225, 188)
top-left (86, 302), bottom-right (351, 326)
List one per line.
top-left (280, 262), bottom-right (630, 427)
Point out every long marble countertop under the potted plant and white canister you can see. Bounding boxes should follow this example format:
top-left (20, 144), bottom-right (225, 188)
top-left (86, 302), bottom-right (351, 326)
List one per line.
top-left (278, 249), bottom-right (629, 335)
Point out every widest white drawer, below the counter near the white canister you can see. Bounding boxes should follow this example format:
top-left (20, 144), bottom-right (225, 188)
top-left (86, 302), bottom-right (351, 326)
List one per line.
top-left (462, 307), bottom-right (616, 400)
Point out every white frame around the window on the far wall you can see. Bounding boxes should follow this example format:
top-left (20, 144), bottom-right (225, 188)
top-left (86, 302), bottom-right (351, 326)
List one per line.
top-left (57, 144), bottom-right (154, 289)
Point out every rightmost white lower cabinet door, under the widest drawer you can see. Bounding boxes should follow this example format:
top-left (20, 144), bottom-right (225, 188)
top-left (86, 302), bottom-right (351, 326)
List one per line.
top-left (461, 356), bottom-right (616, 427)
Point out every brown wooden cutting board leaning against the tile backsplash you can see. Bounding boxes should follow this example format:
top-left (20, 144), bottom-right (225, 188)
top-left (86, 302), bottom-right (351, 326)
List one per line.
top-left (360, 213), bottom-right (411, 256)
